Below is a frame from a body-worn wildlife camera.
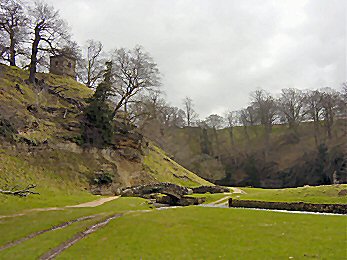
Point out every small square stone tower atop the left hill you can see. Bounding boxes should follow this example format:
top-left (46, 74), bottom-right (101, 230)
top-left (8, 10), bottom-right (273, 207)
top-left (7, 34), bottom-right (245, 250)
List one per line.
top-left (49, 55), bottom-right (76, 79)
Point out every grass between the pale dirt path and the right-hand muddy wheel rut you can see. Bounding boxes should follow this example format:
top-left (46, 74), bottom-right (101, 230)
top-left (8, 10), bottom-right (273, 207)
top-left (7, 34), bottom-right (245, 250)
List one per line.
top-left (0, 198), bottom-right (149, 259)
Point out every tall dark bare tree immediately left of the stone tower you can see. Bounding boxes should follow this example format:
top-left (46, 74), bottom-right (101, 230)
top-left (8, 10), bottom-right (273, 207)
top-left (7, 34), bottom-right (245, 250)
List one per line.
top-left (29, 2), bottom-right (70, 82)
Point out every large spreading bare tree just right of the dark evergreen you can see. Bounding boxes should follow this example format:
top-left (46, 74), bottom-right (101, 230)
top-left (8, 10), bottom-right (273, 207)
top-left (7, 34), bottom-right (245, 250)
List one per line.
top-left (112, 46), bottom-right (160, 119)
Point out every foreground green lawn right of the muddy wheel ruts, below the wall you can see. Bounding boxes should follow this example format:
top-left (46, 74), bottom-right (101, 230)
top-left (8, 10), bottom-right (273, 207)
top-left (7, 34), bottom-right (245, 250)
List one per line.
top-left (58, 207), bottom-right (346, 259)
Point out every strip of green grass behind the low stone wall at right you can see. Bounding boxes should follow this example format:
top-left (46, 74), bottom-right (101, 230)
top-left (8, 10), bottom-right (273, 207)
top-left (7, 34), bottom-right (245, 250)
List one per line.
top-left (232, 184), bottom-right (347, 204)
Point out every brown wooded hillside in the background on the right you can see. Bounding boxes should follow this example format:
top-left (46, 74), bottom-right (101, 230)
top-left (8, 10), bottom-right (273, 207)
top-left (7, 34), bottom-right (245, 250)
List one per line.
top-left (142, 116), bottom-right (347, 188)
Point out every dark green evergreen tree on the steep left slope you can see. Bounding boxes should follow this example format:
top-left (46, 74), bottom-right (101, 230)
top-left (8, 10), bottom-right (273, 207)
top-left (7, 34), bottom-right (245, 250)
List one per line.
top-left (81, 62), bottom-right (113, 147)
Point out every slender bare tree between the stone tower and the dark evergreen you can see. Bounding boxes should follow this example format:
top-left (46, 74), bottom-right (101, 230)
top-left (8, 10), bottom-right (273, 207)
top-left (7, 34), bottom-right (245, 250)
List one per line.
top-left (77, 40), bottom-right (105, 88)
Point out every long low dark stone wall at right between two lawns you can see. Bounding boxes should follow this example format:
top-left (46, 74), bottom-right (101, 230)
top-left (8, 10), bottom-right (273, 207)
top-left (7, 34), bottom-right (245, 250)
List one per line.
top-left (229, 198), bottom-right (347, 214)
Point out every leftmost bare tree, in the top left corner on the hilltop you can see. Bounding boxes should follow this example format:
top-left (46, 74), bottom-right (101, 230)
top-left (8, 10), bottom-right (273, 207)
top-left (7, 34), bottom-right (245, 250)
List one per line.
top-left (0, 0), bottom-right (28, 66)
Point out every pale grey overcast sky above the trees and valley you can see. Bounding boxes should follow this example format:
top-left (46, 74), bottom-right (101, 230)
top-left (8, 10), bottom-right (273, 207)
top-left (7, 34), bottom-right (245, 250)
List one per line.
top-left (42, 0), bottom-right (347, 118)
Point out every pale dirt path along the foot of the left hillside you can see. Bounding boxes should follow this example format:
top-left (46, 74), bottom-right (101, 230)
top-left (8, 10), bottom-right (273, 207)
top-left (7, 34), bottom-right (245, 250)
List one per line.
top-left (0, 196), bottom-right (119, 219)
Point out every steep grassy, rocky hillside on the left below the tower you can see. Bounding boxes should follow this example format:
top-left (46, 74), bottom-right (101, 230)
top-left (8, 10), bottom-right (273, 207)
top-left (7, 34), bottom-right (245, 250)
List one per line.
top-left (0, 64), bottom-right (212, 204)
